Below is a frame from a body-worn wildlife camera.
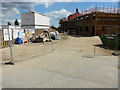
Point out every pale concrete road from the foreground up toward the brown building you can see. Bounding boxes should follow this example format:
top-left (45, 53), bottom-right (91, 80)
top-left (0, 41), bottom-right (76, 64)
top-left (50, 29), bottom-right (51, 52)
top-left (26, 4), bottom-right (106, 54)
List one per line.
top-left (2, 37), bottom-right (118, 88)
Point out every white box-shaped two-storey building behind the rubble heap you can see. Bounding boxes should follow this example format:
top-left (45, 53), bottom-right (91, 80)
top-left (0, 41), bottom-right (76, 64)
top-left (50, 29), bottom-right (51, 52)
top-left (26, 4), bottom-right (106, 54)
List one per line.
top-left (21, 11), bottom-right (50, 33)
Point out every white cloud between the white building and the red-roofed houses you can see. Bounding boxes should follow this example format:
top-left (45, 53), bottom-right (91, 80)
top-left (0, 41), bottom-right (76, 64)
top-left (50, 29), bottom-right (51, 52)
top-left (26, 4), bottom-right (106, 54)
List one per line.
top-left (45, 9), bottom-right (71, 26)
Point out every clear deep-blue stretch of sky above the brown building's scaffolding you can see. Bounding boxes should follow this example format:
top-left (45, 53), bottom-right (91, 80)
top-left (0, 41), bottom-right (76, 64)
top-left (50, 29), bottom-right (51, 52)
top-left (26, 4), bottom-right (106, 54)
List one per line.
top-left (35, 2), bottom-right (117, 13)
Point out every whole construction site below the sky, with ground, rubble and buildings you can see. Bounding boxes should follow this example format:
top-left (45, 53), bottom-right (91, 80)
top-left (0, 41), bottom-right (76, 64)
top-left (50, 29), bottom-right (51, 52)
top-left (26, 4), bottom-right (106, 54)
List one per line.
top-left (0, 1), bottom-right (120, 88)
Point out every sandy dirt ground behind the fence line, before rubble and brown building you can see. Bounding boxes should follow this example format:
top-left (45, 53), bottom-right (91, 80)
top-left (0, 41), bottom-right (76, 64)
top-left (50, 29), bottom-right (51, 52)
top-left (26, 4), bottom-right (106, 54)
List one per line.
top-left (2, 34), bottom-right (114, 62)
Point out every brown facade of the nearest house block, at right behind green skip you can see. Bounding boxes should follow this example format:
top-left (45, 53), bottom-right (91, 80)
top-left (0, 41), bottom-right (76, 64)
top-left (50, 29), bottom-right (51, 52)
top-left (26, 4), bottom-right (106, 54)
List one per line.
top-left (76, 12), bottom-right (120, 36)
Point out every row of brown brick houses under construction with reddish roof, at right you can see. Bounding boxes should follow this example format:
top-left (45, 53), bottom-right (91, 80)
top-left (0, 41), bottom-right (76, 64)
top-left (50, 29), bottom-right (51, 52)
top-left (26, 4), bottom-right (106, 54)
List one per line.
top-left (59, 9), bottom-right (120, 36)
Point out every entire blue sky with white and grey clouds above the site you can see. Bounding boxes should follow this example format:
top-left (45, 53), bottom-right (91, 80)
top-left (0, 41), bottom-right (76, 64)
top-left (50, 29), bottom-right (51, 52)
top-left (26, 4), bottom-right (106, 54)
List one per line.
top-left (0, 0), bottom-right (119, 27)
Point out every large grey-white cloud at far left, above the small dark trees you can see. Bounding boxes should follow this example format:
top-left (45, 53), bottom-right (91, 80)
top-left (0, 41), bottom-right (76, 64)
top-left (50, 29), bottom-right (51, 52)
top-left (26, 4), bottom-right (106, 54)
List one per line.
top-left (0, 2), bottom-right (35, 25)
